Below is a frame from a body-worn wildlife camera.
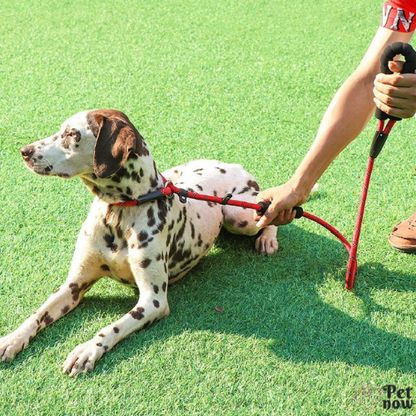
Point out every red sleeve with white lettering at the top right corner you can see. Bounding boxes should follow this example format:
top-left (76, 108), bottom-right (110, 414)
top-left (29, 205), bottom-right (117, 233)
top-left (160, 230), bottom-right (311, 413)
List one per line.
top-left (380, 0), bottom-right (416, 32)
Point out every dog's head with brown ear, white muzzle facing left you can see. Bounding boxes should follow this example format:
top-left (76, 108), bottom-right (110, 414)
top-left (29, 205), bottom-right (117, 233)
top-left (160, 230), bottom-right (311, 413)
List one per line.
top-left (20, 110), bottom-right (149, 178)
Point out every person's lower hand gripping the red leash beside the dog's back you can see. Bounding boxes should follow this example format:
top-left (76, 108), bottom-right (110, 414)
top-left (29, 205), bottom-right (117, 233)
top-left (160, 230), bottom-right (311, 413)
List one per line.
top-left (254, 181), bottom-right (309, 228)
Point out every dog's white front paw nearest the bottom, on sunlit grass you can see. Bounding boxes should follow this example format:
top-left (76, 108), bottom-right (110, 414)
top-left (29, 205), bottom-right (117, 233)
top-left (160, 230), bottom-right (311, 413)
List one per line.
top-left (63, 340), bottom-right (104, 377)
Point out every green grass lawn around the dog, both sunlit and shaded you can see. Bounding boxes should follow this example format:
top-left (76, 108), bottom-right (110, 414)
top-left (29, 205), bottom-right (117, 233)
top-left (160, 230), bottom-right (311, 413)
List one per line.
top-left (0, 0), bottom-right (416, 416)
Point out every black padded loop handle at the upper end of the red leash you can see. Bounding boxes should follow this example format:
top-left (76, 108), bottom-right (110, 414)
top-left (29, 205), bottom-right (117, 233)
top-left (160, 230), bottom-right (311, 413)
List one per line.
top-left (375, 42), bottom-right (416, 120)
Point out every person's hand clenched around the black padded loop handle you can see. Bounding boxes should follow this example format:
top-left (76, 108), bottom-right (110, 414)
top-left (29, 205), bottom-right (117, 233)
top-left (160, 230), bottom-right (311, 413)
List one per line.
top-left (373, 61), bottom-right (416, 118)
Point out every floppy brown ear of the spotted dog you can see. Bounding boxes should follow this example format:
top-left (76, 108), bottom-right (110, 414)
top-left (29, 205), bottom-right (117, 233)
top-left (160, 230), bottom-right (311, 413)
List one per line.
top-left (93, 112), bottom-right (143, 178)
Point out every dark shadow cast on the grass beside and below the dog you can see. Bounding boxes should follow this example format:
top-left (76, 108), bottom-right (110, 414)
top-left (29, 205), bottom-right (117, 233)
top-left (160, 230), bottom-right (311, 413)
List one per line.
top-left (3, 225), bottom-right (416, 376)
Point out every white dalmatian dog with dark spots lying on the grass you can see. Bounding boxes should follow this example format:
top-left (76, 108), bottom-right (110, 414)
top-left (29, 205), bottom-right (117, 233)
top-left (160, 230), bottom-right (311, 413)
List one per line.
top-left (0, 110), bottom-right (278, 376)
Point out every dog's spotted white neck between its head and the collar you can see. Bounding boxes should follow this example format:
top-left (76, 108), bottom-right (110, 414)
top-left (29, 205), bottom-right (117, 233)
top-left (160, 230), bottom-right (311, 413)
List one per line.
top-left (80, 153), bottom-right (163, 204)
